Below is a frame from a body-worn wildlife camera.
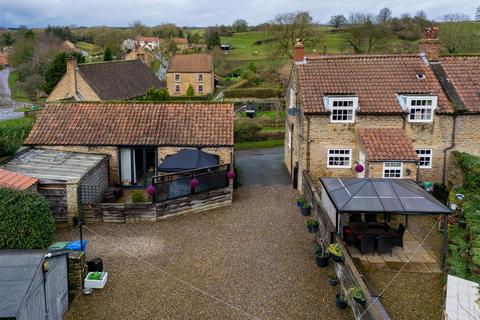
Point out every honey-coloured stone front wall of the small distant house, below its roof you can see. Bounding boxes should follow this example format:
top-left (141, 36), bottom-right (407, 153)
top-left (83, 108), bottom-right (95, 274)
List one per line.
top-left (167, 72), bottom-right (215, 96)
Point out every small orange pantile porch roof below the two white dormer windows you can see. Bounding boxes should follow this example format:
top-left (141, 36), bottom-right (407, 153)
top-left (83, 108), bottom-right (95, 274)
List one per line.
top-left (357, 128), bottom-right (418, 161)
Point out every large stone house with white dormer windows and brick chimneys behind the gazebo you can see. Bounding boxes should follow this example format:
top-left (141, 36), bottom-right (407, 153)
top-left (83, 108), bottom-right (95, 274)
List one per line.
top-left (285, 28), bottom-right (480, 188)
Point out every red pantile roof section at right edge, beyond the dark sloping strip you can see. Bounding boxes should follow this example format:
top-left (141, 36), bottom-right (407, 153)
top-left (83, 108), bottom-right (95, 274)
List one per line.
top-left (440, 56), bottom-right (480, 112)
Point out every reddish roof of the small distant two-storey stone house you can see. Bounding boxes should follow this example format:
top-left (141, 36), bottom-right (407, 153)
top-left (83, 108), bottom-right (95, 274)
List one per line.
top-left (168, 53), bottom-right (213, 72)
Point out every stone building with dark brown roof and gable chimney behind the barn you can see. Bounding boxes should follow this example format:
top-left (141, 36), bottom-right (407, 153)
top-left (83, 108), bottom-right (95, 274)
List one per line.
top-left (47, 58), bottom-right (165, 102)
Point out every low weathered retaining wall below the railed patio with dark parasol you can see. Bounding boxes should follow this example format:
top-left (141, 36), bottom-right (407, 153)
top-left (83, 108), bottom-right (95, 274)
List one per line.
top-left (83, 186), bottom-right (233, 223)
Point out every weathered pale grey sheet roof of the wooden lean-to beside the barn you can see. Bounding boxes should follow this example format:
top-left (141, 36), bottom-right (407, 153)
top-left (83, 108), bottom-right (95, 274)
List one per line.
top-left (2, 148), bottom-right (108, 183)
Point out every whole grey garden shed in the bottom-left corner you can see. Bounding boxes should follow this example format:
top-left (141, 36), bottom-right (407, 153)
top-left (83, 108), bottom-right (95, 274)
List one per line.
top-left (0, 250), bottom-right (68, 320)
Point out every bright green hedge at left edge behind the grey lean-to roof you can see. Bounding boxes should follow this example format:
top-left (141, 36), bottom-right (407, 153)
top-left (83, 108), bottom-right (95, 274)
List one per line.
top-left (0, 118), bottom-right (34, 157)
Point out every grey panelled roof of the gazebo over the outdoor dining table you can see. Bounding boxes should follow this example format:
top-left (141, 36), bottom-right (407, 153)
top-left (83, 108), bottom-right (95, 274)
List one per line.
top-left (320, 178), bottom-right (451, 215)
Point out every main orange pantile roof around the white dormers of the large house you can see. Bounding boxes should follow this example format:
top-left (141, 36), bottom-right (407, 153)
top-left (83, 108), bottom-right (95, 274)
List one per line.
top-left (296, 55), bottom-right (453, 113)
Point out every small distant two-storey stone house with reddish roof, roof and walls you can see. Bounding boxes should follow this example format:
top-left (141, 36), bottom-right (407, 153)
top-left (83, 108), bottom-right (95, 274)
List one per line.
top-left (167, 53), bottom-right (215, 96)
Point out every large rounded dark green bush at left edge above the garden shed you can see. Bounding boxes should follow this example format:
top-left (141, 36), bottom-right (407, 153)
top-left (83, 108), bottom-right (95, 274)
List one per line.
top-left (0, 188), bottom-right (55, 249)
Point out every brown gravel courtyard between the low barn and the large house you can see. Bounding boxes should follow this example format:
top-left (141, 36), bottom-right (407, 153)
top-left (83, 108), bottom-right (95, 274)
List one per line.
top-left (57, 186), bottom-right (351, 319)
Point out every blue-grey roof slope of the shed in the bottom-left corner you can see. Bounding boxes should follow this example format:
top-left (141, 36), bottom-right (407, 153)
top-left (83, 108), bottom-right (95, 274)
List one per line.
top-left (0, 250), bottom-right (45, 318)
